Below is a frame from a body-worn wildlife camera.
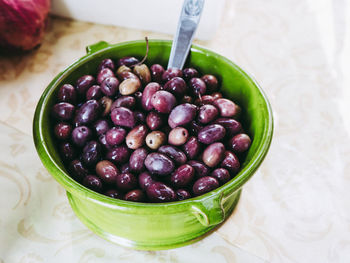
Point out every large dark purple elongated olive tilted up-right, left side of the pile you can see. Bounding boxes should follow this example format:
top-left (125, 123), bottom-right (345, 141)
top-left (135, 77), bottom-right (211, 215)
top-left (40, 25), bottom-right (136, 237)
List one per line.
top-left (74, 100), bottom-right (100, 126)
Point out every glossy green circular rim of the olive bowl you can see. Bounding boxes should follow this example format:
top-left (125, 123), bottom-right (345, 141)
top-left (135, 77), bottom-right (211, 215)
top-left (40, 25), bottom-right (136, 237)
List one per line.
top-left (33, 39), bottom-right (273, 209)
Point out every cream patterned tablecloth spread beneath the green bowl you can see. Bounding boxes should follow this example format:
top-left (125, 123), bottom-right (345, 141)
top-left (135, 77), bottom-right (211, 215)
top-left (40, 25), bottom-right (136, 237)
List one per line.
top-left (0, 0), bottom-right (350, 263)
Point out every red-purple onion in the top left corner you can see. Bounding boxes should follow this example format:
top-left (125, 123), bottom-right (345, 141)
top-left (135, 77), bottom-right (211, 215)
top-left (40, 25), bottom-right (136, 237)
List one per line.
top-left (0, 0), bottom-right (50, 50)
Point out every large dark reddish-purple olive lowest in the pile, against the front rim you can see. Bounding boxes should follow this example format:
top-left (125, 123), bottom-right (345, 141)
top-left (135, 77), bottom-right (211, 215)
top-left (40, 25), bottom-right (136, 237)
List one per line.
top-left (146, 182), bottom-right (176, 203)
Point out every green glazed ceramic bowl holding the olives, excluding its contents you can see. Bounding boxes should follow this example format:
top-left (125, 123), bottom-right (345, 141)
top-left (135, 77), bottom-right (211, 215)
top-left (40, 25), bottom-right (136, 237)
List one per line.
top-left (33, 40), bottom-right (273, 250)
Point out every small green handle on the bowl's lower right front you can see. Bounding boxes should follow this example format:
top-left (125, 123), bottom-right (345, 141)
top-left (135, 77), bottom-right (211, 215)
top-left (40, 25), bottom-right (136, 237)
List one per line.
top-left (191, 195), bottom-right (225, 227)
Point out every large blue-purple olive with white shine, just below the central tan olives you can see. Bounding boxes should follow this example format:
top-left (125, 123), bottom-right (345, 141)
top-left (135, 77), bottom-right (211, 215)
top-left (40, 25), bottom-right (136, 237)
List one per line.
top-left (145, 153), bottom-right (175, 176)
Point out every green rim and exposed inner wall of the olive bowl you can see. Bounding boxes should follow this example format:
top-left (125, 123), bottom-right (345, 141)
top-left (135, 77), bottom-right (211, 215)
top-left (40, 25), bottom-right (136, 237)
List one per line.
top-left (33, 41), bottom-right (273, 205)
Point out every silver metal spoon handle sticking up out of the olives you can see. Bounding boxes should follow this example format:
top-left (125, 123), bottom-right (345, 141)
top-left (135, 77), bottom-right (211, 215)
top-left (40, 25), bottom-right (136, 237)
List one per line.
top-left (168, 0), bottom-right (204, 69)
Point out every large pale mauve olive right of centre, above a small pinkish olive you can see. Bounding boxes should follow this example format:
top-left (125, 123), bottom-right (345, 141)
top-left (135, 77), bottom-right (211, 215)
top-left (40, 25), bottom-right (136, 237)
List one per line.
top-left (168, 103), bottom-right (197, 128)
